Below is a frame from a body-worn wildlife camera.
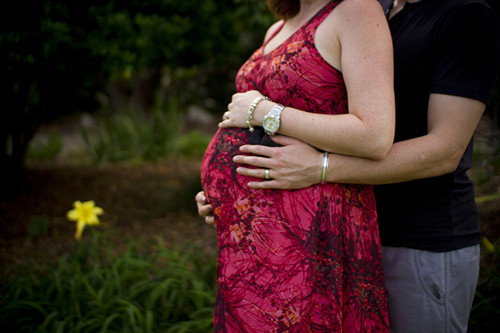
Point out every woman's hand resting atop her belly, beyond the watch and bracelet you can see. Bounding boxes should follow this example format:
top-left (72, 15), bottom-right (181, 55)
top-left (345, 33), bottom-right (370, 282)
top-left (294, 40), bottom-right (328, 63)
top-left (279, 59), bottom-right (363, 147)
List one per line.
top-left (219, 90), bottom-right (262, 128)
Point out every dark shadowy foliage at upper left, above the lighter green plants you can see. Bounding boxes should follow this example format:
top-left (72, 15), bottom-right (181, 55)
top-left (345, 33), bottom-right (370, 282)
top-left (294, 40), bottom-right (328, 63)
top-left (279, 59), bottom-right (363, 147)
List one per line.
top-left (0, 0), bottom-right (272, 181)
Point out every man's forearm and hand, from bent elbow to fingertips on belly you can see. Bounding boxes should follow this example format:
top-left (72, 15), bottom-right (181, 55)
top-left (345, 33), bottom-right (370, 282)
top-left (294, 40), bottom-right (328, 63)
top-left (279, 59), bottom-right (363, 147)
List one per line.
top-left (234, 134), bottom-right (464, 189)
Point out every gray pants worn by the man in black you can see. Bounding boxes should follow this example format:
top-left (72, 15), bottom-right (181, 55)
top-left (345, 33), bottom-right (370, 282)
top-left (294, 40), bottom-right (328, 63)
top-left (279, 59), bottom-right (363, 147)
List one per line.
top-left (382, 245), bottom-right (479, 333)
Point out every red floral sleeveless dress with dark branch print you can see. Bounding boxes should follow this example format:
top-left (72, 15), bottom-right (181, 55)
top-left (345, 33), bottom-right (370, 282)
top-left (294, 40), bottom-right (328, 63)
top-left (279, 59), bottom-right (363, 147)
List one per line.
top-left (201, 1), bottom-right (388, 333)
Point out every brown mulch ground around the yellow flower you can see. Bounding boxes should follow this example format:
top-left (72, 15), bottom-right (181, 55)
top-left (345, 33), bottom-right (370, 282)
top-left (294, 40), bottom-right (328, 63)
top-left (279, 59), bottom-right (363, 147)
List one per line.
top-left (0, 160), bottom-right (217, 274)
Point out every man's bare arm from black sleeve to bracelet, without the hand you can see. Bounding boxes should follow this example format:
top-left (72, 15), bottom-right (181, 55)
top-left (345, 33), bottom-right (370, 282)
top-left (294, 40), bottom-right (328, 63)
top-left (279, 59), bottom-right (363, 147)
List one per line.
top-left (328, 94), bottom-right (485, 184)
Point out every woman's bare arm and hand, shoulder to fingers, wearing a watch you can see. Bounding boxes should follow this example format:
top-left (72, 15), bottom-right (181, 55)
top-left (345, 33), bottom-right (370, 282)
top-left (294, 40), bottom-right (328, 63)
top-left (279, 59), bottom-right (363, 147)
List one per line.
top-left (219, 0), bottom-right (394, 159)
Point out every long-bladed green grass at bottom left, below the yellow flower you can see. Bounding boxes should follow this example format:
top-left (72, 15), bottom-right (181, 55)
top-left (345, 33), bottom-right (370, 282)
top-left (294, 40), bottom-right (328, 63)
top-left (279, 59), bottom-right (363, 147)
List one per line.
top-left (0, 233), bottom-right (215, 333)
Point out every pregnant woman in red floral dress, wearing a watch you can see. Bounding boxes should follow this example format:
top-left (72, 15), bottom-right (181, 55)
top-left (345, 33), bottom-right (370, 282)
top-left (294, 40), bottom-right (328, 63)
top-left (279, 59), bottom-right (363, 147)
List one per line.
top-left (201, 0), bottom-right (394, 333)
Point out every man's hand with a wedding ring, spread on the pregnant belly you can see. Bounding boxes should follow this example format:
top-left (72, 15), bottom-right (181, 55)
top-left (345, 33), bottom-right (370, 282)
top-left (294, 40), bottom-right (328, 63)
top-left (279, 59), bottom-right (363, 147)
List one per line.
top-left (233, 135), bottom-right (322, 189)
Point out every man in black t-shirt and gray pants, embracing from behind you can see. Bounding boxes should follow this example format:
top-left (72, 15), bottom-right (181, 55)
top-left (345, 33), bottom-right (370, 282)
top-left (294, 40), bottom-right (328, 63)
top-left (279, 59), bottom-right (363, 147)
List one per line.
top-left (197, 0), bottom-right (500, 333)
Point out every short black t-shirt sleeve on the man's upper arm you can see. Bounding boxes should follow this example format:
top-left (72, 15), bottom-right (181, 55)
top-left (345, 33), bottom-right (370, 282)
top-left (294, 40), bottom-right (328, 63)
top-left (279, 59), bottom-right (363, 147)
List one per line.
top-left (431, 3), bottom-right (500, 104)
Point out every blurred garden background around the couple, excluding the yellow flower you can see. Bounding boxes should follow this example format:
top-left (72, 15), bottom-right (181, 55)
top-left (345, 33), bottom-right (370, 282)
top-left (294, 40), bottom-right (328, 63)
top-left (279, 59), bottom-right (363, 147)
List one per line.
top-left (0, 0), bottom-right (500, 332)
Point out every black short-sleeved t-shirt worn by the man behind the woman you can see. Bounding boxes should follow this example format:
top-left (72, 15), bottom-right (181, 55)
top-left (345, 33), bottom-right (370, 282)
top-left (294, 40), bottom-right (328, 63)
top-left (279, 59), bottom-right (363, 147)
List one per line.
top-left (375, 0), bottom-right (500, 251)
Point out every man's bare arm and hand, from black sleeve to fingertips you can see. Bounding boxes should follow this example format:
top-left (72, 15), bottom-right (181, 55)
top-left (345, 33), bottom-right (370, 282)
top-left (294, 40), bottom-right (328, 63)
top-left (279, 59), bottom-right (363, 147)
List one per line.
top-left (234, 94), bottom-right (485, 189)
